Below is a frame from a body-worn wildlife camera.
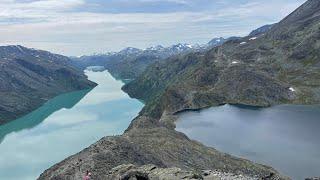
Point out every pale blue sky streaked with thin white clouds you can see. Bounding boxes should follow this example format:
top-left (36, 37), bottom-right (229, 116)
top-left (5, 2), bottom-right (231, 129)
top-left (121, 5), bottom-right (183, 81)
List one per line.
top-left (0, 0), bottom-right (306, 56)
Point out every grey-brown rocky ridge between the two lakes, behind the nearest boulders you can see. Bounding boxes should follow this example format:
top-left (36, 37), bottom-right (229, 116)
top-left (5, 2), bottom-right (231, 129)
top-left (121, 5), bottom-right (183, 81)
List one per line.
top-left (39, 122), bottom-right (287, 180)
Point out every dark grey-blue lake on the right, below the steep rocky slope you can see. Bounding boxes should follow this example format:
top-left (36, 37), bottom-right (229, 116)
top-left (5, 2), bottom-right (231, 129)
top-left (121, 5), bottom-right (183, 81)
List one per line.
top-left (176, 105), bottom-right (320, 180)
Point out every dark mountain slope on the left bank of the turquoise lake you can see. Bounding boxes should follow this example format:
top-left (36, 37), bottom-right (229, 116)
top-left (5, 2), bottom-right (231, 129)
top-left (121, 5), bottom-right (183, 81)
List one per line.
top-left (0, 46), bottom-right (95, 124)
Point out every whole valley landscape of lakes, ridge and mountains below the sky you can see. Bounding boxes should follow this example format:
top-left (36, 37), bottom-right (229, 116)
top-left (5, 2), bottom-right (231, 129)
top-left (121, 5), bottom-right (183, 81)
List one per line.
top-left (0, 0), bottom-right (320, 180)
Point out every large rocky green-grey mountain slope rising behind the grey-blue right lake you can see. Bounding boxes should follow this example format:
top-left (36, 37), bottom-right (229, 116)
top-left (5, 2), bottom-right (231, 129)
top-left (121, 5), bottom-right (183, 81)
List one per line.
top-left (123, 0), bottom-right (320, 118)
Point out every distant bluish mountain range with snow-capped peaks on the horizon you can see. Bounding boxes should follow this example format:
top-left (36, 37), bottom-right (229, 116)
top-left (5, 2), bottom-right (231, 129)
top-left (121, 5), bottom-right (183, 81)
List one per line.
top-left (71, 37), bottom-right (248, 79)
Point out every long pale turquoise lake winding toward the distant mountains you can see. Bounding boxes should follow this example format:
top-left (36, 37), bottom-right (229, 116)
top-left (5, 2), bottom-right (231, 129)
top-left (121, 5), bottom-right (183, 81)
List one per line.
top-left (0, 71), bottom-right (143, 180)
